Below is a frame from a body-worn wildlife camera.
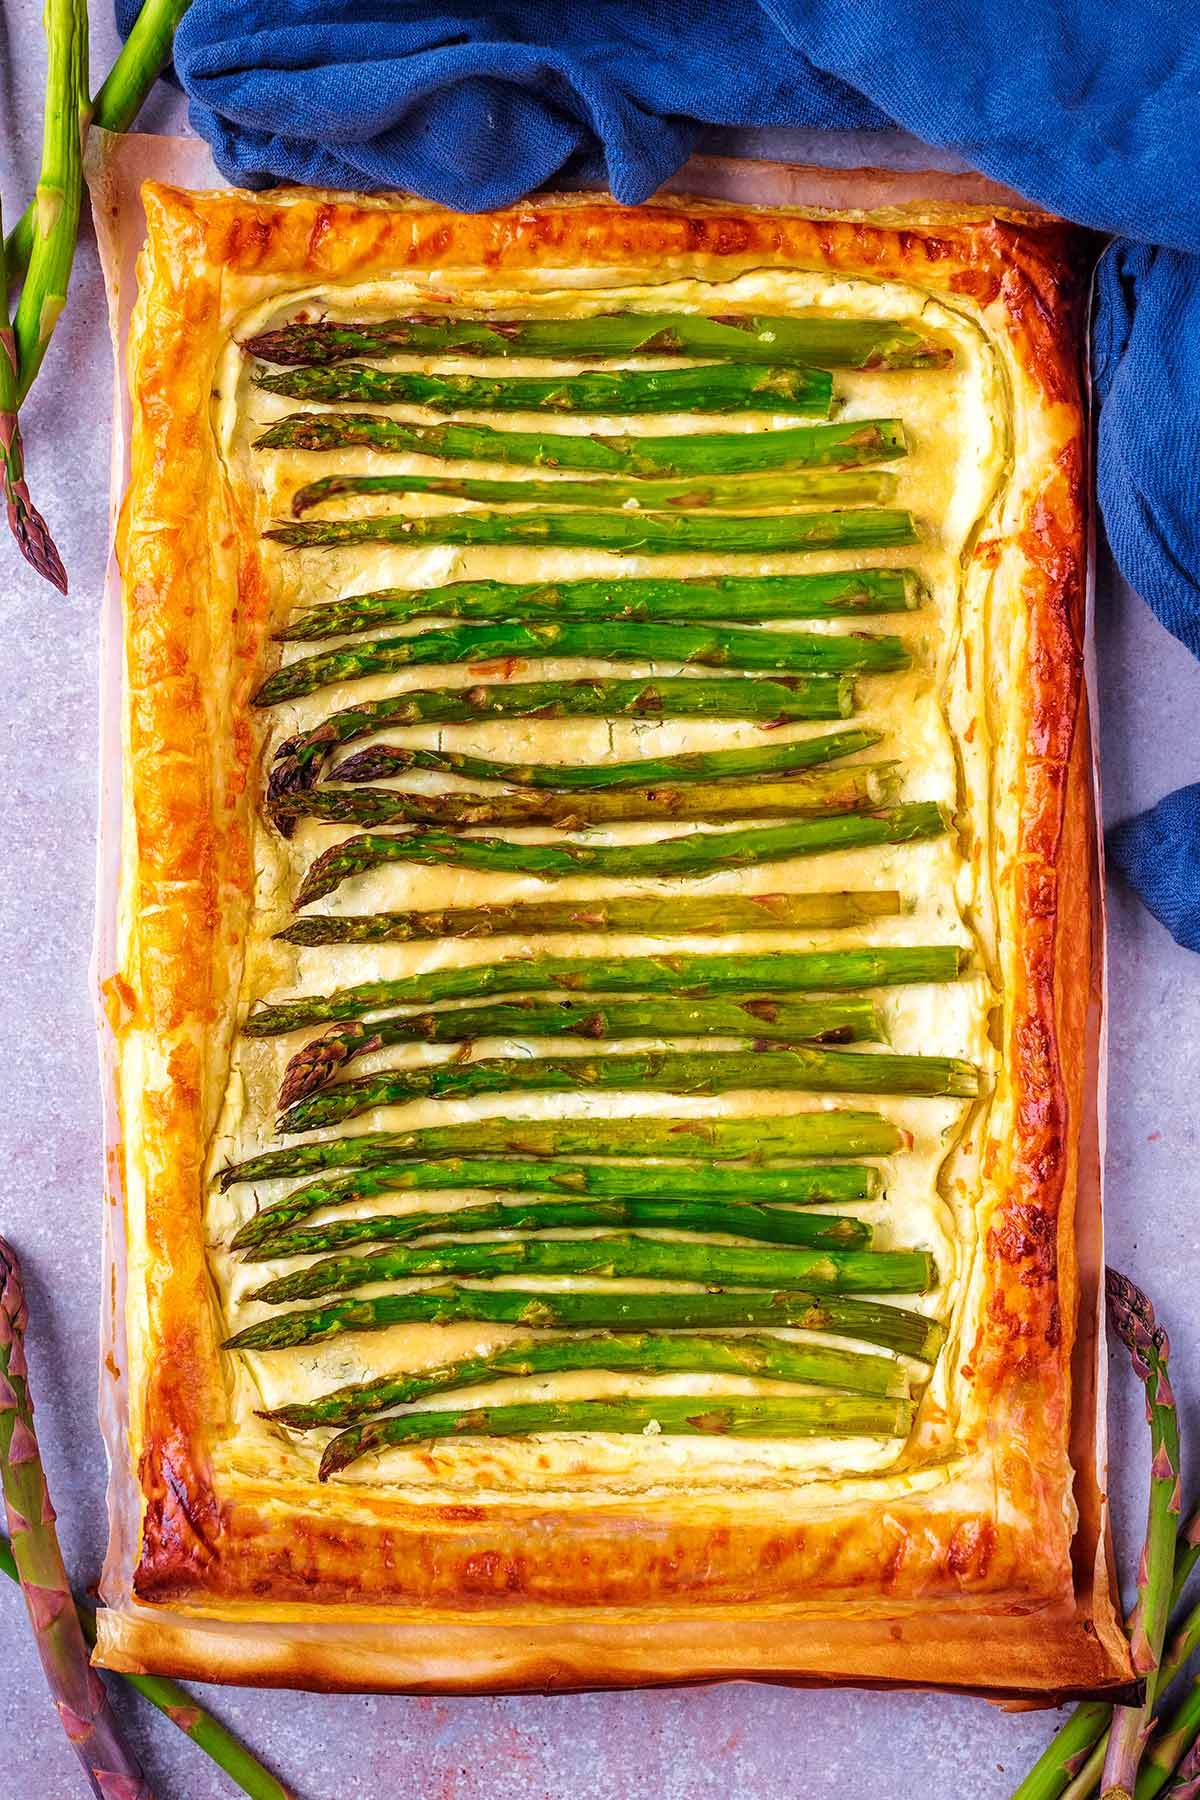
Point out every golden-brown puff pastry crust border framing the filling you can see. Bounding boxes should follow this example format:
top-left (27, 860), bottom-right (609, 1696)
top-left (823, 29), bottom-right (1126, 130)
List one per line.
top-left (101, 175), bottom-right (1128, 1694)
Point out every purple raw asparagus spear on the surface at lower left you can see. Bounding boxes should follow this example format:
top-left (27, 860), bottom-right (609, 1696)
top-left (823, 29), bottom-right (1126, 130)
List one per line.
top-left (0, 1238), bottom-right (153, 1800)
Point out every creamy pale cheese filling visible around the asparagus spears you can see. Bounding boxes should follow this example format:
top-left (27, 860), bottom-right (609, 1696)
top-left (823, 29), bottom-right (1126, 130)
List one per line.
top-left (205, 272), bottom-right (1013, 1507)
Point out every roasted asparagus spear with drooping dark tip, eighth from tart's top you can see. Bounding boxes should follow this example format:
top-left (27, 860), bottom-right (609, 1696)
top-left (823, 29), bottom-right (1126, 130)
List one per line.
top-left (270, 675), bottom-right (855, 799)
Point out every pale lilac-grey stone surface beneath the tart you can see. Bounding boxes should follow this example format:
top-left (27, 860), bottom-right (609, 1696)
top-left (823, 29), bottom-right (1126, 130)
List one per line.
top-left (0, 0), bottom-right (1200, 1800)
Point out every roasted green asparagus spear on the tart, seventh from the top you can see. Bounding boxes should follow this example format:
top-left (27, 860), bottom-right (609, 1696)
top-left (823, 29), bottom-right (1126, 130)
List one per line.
top-left (254, 623), bottom-right (909, 706)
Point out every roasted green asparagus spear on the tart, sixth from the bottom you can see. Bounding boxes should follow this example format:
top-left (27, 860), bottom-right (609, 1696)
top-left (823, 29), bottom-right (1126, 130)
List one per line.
top-left (230, 1152), bottom-right (880, 1249)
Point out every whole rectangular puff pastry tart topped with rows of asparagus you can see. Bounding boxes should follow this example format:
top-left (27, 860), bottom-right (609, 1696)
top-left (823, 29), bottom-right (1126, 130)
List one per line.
top-left (99, 187), bottom-right (1128, 1696)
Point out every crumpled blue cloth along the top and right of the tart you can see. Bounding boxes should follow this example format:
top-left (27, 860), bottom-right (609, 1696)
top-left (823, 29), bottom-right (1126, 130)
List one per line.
top-left (119, 0), bottom-right (1200, 949)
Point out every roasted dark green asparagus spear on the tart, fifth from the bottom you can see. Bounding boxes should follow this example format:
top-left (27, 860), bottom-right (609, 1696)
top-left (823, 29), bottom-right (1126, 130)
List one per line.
top-left (243, 1201), bottom-right (873, 1262)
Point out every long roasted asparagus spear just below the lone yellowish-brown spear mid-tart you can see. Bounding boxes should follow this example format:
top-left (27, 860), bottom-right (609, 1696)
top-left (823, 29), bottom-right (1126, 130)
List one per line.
top-left (245, 943), bottom-right (966, 1037)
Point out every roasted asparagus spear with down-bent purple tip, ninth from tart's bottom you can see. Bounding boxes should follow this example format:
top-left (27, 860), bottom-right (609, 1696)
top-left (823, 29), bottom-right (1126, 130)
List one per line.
top-left (279, 995), bottom-right (887, 1107)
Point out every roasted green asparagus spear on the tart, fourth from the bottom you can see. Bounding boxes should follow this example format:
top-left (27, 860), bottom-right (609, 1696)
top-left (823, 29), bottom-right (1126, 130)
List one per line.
top-left (246, 1237), bottom-right (937, 1305)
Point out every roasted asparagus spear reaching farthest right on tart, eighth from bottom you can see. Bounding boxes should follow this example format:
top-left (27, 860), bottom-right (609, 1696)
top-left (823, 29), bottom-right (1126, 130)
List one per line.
top-left (279, 1048), bottom-right (979, 1136)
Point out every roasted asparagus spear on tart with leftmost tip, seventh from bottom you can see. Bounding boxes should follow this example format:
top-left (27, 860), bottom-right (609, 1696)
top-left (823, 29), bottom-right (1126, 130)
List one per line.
top-left (219, 1111), bottom-right (909, 1206)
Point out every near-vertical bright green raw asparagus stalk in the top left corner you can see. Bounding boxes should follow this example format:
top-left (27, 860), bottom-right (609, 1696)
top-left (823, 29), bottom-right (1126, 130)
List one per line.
top-left (13, 0), bottom-right (90, 401)
